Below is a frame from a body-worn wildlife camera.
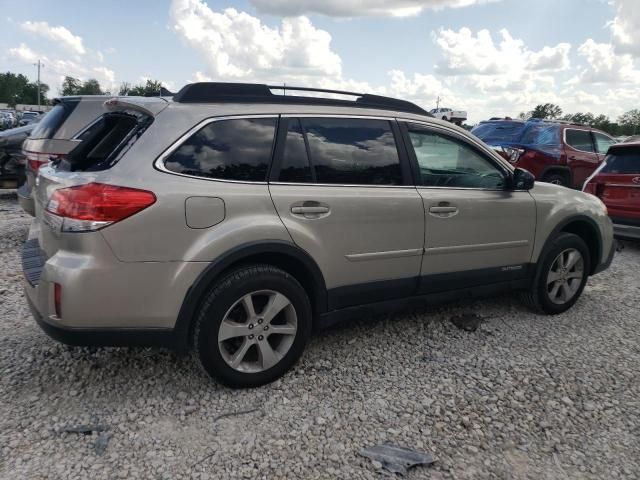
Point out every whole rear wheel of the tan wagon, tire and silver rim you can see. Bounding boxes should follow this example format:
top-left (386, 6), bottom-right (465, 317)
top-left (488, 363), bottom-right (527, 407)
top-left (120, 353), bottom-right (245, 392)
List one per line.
top-left (194, 265), bottom-right (311, 387)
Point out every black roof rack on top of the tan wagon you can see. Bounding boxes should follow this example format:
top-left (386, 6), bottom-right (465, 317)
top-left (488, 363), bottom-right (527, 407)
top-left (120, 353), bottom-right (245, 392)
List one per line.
top-left (173, 82), bottom-right (432, 116)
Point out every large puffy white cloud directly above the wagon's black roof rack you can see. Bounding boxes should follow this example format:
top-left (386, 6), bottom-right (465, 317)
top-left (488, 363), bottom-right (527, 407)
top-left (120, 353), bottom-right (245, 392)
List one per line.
top-left (170, 0), bottom-right (342, 79)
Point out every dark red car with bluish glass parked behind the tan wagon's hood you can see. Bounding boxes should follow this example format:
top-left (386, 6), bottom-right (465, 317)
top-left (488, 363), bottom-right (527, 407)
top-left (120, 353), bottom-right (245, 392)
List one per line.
top-left (471, 119), bottom-right (616, 188)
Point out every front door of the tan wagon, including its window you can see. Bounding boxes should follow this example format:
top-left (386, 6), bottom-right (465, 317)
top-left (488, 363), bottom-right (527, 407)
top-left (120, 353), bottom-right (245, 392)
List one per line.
top-left (402, 123), bottom-right (536, 293)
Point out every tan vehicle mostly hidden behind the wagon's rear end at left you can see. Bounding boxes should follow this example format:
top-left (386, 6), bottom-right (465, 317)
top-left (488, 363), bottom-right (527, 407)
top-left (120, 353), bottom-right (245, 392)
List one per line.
top-left (18, 95), bottom-right (112, 215)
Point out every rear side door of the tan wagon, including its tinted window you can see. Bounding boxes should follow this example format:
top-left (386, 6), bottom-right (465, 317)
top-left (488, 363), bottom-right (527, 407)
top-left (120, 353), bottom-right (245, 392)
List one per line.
top-left (269, 116), bottom-right (424, 309)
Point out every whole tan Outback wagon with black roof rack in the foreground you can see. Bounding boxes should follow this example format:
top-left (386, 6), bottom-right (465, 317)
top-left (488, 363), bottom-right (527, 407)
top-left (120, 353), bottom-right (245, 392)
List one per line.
top-left (23, 83), bottom-right (614, 387)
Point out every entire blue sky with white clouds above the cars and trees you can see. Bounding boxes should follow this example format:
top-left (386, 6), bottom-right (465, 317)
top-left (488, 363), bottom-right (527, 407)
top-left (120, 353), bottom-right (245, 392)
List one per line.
top-left (0, 0), bottom-right (640, 123)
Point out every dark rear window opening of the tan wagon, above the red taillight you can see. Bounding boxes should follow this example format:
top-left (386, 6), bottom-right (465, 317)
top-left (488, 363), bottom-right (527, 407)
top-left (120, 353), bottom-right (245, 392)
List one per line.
top-left (65, 112), bottom-right (153, 170)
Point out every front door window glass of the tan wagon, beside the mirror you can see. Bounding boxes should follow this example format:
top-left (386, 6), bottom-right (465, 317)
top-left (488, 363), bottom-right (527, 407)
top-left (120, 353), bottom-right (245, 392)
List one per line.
top-left (409, 128), bottom-right (505, 190)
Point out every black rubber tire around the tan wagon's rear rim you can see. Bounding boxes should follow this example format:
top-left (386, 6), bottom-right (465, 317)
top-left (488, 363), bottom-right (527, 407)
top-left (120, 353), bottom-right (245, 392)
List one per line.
top-left (193, 265), bottom-right (312, 388)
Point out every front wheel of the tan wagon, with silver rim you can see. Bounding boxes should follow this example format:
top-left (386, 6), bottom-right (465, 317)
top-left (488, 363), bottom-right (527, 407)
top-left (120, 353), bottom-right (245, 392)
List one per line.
top-left (524, 233), bottom-right (591, 315)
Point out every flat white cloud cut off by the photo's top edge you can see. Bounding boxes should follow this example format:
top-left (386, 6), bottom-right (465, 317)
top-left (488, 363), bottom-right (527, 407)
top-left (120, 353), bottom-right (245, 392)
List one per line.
top-left (250, 0), bottom-right (495, 17)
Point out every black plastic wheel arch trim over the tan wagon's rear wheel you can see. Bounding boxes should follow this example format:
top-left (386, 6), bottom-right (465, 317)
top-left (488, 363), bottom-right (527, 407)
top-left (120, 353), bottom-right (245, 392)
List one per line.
top-left (174, 240), bottom-right (327, 352)
